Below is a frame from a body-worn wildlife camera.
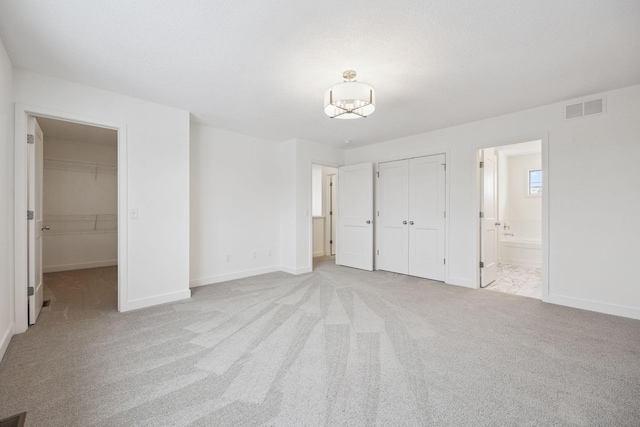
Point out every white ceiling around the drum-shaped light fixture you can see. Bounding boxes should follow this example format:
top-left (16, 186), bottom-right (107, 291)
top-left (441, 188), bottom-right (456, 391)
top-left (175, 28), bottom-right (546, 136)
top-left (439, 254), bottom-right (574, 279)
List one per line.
top-left (0, 0), bottom-right (640, 148)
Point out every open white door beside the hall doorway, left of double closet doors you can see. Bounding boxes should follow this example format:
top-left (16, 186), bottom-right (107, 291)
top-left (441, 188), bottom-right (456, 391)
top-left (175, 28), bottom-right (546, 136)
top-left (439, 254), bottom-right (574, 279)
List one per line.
top-left (336, 163), bottom-right (373, 271)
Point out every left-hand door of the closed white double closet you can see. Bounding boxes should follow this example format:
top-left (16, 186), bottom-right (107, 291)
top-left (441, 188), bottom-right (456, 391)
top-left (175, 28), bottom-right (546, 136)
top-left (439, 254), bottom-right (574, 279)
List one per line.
top-left (376, 160), bottom-right (409, 274)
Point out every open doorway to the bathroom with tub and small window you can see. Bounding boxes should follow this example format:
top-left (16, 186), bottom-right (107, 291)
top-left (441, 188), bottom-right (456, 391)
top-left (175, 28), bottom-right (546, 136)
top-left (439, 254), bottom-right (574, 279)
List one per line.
top-left (478, 140), bottom-right (545, 299)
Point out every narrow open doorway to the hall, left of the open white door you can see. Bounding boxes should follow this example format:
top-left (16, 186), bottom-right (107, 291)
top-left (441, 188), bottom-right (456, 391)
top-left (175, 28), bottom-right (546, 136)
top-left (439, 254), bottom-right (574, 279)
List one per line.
top-left (311, 164), bottom-right (338, 269)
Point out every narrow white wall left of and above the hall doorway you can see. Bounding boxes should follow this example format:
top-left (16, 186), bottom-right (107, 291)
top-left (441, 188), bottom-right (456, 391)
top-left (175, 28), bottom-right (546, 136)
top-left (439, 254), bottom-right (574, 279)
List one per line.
top-left (280, 139), bottom-right (344, 274)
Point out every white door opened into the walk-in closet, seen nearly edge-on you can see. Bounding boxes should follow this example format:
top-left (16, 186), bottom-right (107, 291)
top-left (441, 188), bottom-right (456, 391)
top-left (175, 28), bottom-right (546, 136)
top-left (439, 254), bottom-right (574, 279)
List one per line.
top-left (27, 116), bottom-right (44, 325)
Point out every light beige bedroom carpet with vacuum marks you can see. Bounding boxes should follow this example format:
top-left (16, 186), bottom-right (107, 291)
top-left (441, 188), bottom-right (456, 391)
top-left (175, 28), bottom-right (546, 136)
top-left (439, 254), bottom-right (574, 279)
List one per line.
top-left (0, 259), bottom-right (640, 426)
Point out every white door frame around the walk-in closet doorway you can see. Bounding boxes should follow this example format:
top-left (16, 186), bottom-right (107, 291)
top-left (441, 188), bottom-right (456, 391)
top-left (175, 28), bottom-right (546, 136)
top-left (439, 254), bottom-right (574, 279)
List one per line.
top-left (14, 103), bottom-right (128, 333)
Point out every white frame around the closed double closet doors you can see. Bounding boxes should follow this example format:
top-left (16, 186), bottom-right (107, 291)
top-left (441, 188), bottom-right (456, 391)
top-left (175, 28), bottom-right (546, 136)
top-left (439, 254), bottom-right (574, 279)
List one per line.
top-left (373, 148), bottom-right (451, 283)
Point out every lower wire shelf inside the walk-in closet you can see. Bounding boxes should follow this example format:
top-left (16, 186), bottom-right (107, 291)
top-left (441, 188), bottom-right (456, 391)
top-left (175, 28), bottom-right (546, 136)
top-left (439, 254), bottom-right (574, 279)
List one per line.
top-left (43, 214), bottom-right (118, 236)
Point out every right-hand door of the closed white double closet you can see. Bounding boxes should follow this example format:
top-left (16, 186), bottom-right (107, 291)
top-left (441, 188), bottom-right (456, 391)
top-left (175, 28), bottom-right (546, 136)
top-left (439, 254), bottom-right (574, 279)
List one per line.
top-left (409, 154), bottom-right (446, 281)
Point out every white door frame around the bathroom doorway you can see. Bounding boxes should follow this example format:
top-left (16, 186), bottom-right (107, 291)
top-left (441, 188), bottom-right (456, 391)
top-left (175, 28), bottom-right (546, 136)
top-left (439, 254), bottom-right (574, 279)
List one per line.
top-left (471, 132), bottom-right (550, 302)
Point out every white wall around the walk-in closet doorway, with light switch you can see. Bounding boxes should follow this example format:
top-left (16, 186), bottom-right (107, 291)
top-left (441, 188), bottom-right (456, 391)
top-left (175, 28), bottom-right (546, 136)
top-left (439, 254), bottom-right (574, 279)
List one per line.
top-left (14, 70), bottom-right (190, 310)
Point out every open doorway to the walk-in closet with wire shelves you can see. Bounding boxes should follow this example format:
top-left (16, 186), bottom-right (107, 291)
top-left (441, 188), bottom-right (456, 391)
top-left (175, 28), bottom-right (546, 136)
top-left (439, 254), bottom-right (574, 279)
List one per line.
top-left (28, 115), bottom-right (118, 325)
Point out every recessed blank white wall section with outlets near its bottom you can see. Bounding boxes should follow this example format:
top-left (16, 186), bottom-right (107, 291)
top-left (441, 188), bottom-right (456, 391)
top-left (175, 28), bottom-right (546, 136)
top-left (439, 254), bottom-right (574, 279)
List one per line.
top-left (190, 125), bottom-right (281, 286)
